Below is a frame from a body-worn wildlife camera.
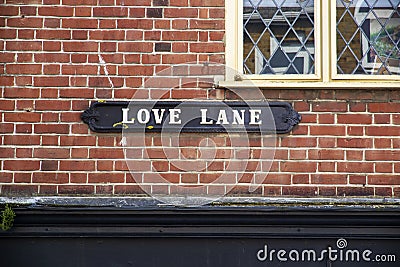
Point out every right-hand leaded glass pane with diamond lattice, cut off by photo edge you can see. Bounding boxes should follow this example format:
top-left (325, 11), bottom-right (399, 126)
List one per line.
top-left (336, 0), bottom-right (400, 75)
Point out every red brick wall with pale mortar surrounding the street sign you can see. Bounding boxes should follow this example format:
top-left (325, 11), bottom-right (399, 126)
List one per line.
top-left (0, 0), bottom-right (400, 197)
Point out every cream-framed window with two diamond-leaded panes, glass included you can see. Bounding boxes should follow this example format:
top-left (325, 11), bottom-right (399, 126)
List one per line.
top-left (223, 0), bottom-right (400, 88)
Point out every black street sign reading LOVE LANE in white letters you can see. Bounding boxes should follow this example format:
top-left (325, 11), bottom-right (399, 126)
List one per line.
top-left (81, 101), bottom-right (301, 134)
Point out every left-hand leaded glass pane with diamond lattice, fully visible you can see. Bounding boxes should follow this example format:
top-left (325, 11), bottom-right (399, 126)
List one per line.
top-left (243, 0), bottom-right (315, 74)
